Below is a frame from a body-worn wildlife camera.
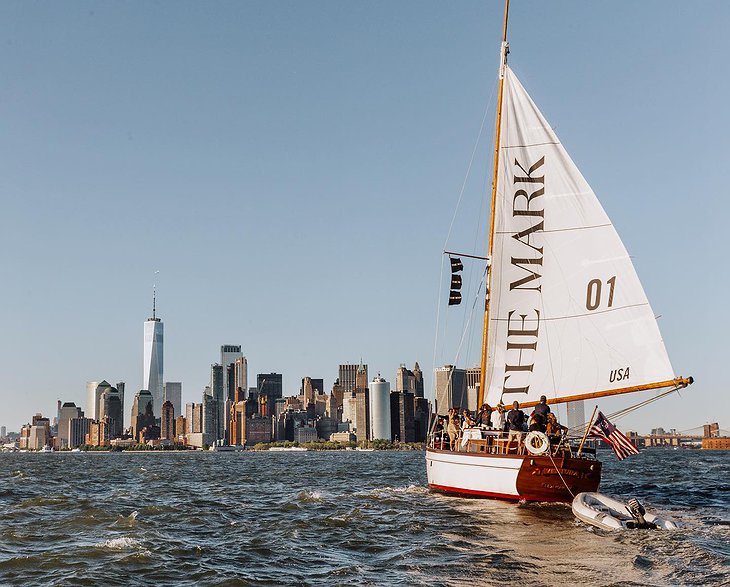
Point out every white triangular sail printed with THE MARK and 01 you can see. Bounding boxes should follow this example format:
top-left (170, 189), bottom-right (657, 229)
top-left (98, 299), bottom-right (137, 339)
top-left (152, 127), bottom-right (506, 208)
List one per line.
top-left (486, 68), bottom-right (674, 405)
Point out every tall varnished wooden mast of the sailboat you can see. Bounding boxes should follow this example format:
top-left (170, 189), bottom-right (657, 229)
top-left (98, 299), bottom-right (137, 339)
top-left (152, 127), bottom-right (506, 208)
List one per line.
top-left (477, 0), bottom-right (509, 409)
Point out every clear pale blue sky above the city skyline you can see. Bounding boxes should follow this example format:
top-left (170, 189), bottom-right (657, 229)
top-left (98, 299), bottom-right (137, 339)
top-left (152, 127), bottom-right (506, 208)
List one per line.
top-left (0, 0), bottom-right (730, 431)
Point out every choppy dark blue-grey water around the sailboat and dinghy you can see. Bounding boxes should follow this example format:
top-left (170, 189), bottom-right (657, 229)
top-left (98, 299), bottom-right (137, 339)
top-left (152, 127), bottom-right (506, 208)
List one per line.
top-left (0, 449), bottom-right (730, 587)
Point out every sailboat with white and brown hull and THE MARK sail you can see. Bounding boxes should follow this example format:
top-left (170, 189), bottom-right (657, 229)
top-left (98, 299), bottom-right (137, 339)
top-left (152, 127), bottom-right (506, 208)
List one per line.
top-left (426, 0), bottom-right (692, 502)
